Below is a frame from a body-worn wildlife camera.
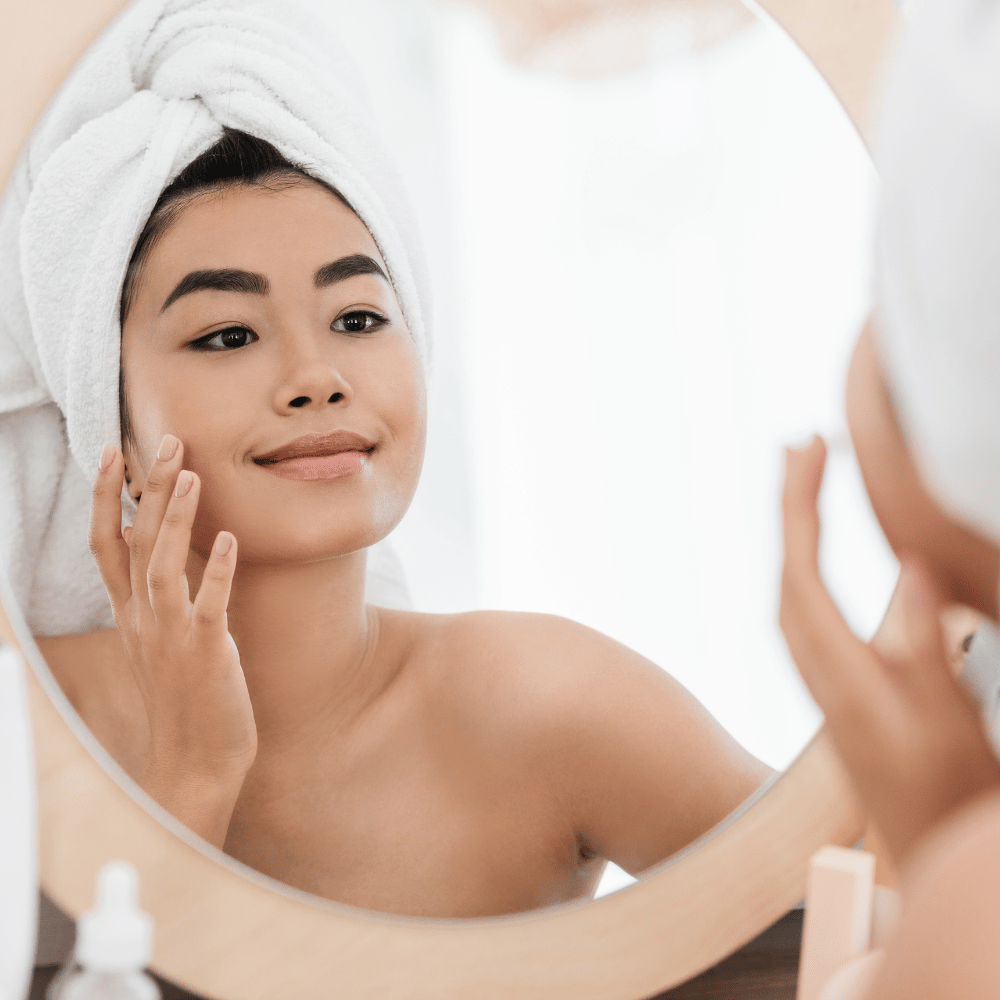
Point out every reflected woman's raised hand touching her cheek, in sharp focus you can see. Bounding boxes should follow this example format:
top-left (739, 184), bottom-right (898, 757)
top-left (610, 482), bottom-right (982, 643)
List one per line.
top-left (90, 434), bottom-right (257, 847)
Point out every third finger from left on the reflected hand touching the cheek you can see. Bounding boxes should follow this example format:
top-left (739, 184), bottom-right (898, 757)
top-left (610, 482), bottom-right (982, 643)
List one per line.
top-left (146, 469), bottom-right (201, 622)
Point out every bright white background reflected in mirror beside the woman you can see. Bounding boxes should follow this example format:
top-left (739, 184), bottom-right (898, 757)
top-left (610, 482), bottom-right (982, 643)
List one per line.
top-left (302, 0), bottom-right (896, 900)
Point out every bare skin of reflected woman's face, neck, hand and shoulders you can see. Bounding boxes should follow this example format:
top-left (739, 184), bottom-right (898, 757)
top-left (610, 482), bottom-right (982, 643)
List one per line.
top-left (39, 181), bottom-right (770, 917)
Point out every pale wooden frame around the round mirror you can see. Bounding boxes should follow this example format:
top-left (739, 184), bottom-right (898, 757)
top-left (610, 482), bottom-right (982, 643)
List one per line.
top-left (0, 0), bottom-right (899, 1000)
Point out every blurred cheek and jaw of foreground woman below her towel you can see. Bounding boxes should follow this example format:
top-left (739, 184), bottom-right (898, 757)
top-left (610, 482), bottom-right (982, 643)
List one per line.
top-left (846, 319), bottom-right (1000, 621)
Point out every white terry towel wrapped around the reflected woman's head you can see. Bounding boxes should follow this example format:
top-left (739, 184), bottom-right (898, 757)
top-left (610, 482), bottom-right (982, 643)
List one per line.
top-left (0, 0), bottom-right (429, 635)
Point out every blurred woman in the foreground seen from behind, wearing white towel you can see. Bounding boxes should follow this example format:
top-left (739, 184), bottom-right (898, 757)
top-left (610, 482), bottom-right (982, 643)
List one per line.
top-left (782, 0), bottom-right (1000, 1000)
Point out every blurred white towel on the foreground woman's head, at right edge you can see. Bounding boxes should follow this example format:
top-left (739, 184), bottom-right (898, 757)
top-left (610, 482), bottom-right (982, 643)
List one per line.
top-left (875, 0), bottom-right (1000, 540)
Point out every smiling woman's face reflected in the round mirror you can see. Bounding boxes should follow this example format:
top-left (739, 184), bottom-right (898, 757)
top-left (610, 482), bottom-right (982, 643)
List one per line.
top-left (121, 181), bottom-right (426, 563)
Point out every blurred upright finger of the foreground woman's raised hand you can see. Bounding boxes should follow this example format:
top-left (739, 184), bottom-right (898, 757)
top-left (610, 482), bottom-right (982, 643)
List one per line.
top-left (780, 438), bottom-right (885, 720)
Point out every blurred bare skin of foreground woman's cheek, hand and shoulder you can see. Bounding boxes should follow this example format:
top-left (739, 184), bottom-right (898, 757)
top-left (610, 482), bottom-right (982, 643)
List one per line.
top-left (781, 321), bottom-right (1000, 1000)
